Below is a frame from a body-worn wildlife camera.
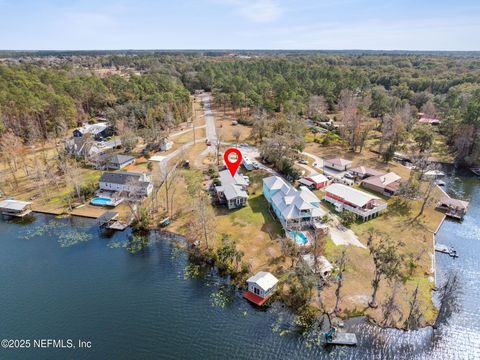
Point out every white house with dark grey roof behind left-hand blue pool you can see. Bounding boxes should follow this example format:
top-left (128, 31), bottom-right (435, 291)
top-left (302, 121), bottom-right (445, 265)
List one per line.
top-left (99, 171), bottom-right (153, 198)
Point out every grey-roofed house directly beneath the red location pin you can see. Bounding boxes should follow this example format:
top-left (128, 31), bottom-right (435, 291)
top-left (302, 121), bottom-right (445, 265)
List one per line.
top-left (215, 170), bottom-right (248, 209)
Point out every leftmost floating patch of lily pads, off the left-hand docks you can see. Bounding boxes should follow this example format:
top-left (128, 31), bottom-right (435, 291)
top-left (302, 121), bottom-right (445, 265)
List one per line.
top-left (23, 220), bottom-right (92, 247)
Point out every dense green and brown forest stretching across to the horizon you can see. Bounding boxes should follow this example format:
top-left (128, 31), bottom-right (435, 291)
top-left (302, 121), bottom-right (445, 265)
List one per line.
top-left (0, 52), bottom-right (480, 165)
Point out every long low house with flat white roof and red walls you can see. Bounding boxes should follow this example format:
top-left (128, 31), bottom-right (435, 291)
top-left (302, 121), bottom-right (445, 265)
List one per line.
top-left (323, 183), bottom-right (387, 221)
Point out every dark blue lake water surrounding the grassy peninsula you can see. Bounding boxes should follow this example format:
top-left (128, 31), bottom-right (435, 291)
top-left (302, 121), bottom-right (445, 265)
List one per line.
top-left (0, 170), bottom-right (480, 359)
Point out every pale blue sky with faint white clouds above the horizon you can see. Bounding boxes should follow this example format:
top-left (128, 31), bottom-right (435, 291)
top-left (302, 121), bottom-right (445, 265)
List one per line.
top-left (0, 0), bottom-right (480, 51)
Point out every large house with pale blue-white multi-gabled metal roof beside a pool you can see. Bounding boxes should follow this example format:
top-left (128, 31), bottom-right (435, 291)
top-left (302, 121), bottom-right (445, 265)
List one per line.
top-left (263, 176), bottom-right (326, 232)
